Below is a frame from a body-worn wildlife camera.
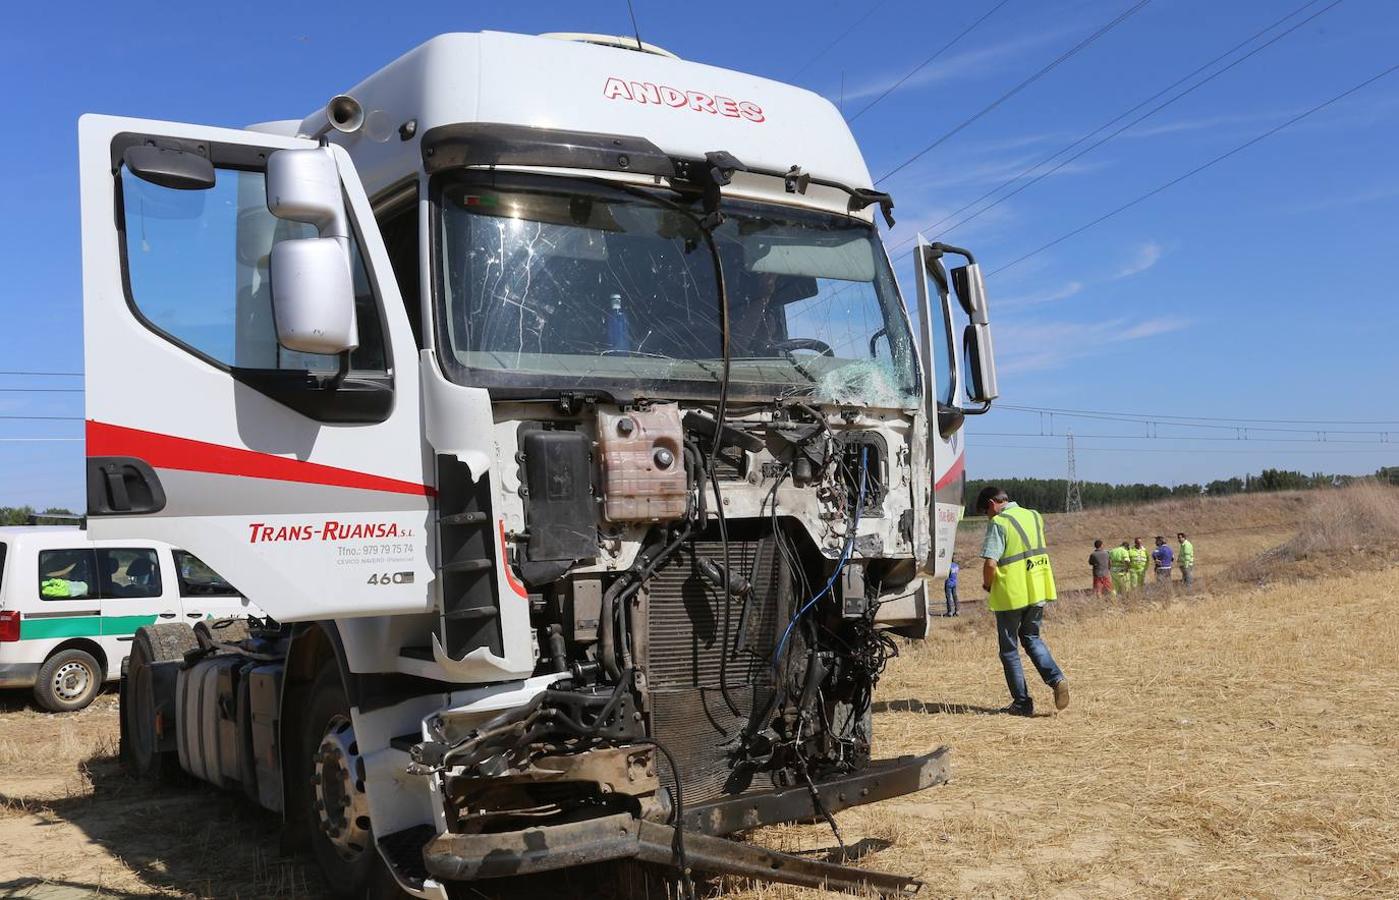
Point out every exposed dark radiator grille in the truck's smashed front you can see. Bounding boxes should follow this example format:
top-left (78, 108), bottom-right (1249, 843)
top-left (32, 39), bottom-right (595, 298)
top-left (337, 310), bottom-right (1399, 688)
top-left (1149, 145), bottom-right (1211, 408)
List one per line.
top-left (646, 540), bottom-right (790, 802)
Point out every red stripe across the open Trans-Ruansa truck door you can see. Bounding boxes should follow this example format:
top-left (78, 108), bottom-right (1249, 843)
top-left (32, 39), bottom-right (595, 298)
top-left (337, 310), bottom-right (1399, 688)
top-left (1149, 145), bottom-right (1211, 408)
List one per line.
top-left (87, 419), bottom-right (436, 497)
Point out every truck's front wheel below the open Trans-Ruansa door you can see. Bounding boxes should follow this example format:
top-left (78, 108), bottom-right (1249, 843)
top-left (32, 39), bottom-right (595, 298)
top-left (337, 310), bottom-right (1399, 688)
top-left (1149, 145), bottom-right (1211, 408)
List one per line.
top-left (294, 659), bottom-right (410, 900)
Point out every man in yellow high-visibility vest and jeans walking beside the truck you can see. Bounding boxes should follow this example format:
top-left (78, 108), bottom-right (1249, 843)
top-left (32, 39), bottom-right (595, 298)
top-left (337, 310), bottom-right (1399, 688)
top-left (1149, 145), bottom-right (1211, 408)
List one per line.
top-left (977, 484), bottom-right (1069, 715)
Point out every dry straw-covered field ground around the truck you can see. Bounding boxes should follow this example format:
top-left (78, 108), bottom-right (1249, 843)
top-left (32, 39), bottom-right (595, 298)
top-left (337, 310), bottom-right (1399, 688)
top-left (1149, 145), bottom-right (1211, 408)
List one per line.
top-left (0, 495), bottom-right (1399, 900)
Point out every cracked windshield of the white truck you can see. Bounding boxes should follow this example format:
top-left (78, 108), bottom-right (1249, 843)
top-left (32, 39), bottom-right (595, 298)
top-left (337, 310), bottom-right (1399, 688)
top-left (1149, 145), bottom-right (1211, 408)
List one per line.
top-left (442, 178), bottom-right (919, 406)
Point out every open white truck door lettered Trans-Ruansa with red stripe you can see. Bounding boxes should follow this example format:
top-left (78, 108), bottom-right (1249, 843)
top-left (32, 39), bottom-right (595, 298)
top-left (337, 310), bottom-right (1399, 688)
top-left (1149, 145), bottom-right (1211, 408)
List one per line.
top-left (78, 115), bottom-right (434, 621)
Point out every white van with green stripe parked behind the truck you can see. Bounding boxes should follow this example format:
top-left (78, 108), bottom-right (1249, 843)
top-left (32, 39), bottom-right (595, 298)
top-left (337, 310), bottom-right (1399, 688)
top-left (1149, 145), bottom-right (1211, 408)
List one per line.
top-left (0, 526), bottom-right (260, 712)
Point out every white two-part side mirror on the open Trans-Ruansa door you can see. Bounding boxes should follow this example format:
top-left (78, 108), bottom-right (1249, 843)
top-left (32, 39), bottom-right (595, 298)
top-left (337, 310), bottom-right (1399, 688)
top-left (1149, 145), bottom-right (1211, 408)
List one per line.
top-left (267, 147), bottom-right (360, 354)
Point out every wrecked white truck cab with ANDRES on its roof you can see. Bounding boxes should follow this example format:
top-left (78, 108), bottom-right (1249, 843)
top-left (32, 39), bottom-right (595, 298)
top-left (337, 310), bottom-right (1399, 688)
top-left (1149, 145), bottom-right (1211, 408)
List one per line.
top-left (81, 32), bottom-right (996, 896)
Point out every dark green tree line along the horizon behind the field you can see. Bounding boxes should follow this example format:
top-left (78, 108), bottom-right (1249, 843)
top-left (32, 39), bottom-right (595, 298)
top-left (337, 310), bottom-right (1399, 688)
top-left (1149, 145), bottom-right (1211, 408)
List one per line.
top-left (965, 466), bottom-right (1399, 515)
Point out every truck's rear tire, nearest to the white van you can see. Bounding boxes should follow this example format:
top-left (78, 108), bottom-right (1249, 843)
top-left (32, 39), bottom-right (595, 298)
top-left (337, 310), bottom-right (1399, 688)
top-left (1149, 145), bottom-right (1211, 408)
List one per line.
top-left (118, 623), bottom-right (199, 778)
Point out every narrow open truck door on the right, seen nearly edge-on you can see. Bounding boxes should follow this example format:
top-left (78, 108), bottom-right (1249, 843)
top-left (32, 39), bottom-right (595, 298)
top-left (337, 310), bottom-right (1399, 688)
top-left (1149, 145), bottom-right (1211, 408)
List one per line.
top-left (914, 234), bottom-right (967, 578)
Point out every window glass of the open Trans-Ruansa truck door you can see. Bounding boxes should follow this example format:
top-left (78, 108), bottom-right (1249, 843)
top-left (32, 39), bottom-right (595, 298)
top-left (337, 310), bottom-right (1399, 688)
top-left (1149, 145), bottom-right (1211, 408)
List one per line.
top-left (118, 168), bottom-right (386, 372)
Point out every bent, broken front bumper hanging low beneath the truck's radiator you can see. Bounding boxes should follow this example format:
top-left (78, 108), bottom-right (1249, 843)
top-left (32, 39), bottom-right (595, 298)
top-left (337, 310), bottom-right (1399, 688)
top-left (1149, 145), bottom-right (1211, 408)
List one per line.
top-left (422, 747), bottom-right (950, 896)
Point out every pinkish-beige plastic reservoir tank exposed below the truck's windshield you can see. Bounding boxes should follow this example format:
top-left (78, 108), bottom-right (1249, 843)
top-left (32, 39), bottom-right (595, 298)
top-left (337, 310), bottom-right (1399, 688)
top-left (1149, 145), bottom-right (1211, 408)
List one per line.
top-left (597, 403), bottom-right (688, 522)
